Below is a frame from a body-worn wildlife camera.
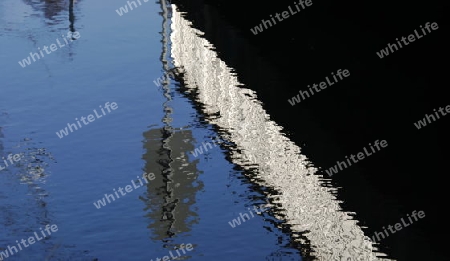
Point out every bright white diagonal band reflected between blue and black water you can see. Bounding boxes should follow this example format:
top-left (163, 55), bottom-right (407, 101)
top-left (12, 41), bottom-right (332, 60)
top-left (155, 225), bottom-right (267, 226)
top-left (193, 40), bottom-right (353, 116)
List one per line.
top-left (171, 5), bottom-right (390, 261)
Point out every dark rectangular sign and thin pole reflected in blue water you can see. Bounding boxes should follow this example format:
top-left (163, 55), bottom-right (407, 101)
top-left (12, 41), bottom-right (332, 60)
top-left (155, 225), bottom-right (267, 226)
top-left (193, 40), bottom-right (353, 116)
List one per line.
top-left (141, 1), bottom-right (204, 252)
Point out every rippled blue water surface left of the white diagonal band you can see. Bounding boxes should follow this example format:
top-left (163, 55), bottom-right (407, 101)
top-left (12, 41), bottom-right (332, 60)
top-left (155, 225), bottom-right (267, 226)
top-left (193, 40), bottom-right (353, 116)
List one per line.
top-left (0, 0), bottom-right (301, 261)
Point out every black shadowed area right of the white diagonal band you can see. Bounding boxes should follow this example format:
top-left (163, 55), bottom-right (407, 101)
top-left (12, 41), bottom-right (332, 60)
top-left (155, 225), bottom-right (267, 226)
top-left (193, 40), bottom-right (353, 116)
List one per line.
top-left (171, 0), bottom-right (450, 260)
